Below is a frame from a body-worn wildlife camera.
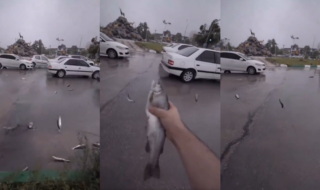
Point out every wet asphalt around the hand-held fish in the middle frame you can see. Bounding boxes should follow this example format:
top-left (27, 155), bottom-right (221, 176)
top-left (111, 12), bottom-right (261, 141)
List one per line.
top-left (100, 53), bottom-right (220, 189)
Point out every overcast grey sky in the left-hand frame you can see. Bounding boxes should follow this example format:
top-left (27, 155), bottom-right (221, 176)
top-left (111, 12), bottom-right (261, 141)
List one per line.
top-left (0, 0), bottom-right (100, 48)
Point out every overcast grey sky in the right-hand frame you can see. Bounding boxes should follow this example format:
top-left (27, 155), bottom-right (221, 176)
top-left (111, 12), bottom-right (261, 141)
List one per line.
top-left (221, 0), bottom-right (320, 48)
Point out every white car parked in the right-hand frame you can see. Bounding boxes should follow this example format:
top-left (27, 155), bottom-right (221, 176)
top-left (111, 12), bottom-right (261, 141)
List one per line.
top-left (221, 51), bottom-right (266, 75)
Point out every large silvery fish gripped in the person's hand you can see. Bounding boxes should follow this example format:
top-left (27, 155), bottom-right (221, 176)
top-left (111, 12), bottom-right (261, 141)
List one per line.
top-left (143, 80), bottom-right (169, 181)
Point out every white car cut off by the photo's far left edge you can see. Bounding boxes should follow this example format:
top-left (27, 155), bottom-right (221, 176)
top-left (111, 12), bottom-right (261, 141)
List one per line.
top-left (0, 54), bottom-right (33, 70)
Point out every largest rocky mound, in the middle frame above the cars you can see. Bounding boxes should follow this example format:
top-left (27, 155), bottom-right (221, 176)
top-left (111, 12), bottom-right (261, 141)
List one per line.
top-left (101, 16), bottom-right (143, 41)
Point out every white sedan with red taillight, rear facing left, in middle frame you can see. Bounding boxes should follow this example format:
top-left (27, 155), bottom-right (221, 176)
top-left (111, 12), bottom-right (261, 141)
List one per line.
top-left (161, 47), bottom-right (221, 82)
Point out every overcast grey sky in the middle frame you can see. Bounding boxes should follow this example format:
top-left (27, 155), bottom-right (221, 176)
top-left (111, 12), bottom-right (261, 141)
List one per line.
top-left (100, 0), bottom-right (220, 36)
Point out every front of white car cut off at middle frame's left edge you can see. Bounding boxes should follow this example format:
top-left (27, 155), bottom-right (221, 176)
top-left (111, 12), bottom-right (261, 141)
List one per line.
top-left (100, 32), bottom-right (130, 59)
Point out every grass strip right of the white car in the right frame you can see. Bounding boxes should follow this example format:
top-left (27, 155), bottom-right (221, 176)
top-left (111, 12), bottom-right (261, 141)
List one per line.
top-left (266, 57), bottom-right (320, 67)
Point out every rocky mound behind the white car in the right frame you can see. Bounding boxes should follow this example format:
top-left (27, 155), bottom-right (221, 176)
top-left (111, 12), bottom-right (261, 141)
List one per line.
top-left (237, 36), bottom-right (271, 57)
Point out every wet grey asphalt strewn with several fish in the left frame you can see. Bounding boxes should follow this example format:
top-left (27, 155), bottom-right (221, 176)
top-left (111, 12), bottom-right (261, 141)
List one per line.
top-left (0, 69), bottom-right (100, 171)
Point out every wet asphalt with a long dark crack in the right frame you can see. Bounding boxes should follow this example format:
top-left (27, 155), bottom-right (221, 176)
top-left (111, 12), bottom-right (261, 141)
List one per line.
top-left (221, 68), bottom-right (320, 190)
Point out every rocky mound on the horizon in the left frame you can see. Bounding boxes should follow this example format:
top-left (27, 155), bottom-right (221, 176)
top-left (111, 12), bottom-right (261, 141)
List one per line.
top-left (5, 39), bottom-right (38, 57)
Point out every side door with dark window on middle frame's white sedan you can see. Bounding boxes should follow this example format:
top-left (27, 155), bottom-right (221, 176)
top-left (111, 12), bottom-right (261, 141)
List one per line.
top-left (195, 50), bottom-right (220, 79)
